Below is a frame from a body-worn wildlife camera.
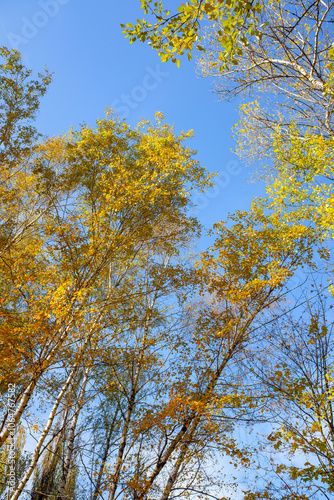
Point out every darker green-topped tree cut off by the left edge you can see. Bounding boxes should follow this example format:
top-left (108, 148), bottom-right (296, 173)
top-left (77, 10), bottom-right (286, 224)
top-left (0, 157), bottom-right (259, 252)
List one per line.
top-left (0, 47), bottom-right (51, 254)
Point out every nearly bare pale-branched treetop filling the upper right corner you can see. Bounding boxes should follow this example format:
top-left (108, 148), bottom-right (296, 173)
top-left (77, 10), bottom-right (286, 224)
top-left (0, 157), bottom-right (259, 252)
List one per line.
top-left (200, 1), bottom-right (334, 162)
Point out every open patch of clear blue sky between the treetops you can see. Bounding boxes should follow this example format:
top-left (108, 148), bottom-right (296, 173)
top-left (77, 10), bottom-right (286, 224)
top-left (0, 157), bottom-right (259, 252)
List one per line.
top-left (0, 0), bottom-right (263, 246)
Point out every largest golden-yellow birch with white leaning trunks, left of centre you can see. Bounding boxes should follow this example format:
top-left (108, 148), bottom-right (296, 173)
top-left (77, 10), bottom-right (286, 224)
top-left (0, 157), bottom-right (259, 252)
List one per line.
top-left (0, 49), bottom-right (218, 500)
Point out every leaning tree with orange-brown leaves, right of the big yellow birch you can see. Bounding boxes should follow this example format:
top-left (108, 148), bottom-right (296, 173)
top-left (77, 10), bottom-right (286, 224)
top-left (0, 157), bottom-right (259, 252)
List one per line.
top-left (96, 206), bottom-right (313, 499)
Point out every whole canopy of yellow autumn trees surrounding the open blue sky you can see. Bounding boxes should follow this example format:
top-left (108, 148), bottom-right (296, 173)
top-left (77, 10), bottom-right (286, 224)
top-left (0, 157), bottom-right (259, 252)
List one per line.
top-left (0, 0), bottom-right (334, 500)
